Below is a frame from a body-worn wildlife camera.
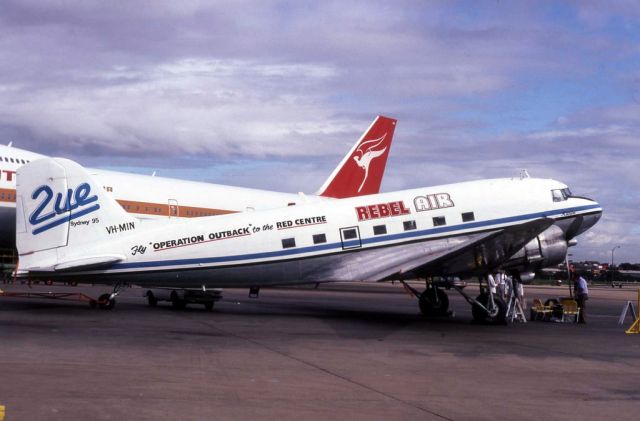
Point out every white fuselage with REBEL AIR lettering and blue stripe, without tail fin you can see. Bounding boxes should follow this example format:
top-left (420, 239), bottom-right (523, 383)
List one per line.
top-left (20, 178), bottom-right (602, 287)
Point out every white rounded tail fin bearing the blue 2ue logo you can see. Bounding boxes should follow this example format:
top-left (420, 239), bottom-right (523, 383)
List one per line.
top-left (16, 158), bottom-right (137, 270)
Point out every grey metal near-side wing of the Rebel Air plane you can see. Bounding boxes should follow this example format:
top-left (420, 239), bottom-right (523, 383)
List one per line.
top-left (305, 218), bottom-right (553, 282)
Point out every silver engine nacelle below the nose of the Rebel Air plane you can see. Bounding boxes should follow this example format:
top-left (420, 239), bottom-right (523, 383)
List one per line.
top-left (502, 225), bottom-right (568, 282)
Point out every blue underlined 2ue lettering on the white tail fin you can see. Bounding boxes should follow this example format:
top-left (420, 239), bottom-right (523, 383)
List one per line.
top-left (29, 183), bottom-right (100, 235)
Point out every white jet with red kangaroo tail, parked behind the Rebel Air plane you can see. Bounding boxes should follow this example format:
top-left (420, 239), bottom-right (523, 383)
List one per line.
top-left (0, 116), bottom-right (396, 248)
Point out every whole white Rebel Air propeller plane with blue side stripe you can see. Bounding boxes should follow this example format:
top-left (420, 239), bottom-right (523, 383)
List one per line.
top-left (16, 158), bottom-right (602, 321)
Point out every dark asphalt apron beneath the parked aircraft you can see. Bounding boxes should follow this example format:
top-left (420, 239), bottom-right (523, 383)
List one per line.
top-left (0, 278), bottom-right (640, 421)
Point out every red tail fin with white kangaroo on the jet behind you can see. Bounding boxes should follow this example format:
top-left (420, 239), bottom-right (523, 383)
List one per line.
top-left (317, 116), bottom-right (396, 199)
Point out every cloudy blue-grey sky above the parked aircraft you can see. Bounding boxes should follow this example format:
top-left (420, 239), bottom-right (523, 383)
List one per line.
top-left (0, 0), bottom-right (640, 263)
